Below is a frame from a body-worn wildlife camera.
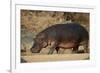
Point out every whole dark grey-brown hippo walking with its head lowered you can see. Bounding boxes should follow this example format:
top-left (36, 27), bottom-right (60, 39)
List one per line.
top-left (31, 23), bottom-right (89, 54)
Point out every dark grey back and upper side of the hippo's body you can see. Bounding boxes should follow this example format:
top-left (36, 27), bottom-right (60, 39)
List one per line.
top-left (43, 23), bottom-right (88, 40)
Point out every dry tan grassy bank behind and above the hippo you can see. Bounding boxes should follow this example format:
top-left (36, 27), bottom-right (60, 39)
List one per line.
top-left (21, 10), bottom-right (89, 33)
